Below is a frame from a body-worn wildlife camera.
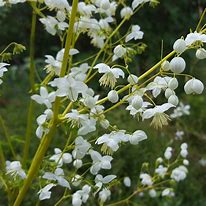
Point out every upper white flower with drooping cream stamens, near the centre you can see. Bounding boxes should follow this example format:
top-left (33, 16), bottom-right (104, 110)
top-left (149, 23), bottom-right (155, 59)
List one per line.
top-left (94, 63), bottom-right (124, 88)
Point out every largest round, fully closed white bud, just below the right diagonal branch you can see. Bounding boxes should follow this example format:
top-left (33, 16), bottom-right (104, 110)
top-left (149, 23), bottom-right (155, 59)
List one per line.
top-left (170, 57), bottom-right (186, 74)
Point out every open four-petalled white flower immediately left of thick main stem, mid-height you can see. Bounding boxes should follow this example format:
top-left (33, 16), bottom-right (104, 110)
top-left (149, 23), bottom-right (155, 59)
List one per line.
top-left (31, 87), bottom-right (55, 108)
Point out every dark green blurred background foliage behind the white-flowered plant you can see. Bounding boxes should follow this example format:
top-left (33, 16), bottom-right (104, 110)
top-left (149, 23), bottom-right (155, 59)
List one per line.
top-left (0, 0), bottom-right (206, 206)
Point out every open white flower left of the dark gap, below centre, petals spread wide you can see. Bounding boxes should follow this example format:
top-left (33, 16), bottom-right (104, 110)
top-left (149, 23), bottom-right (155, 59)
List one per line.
top-left (90, 150), bottom-right (113, 175)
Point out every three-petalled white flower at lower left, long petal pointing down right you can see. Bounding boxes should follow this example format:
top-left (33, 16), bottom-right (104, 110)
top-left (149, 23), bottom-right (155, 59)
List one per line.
top-left (42, 168), bottom-right (71, 189)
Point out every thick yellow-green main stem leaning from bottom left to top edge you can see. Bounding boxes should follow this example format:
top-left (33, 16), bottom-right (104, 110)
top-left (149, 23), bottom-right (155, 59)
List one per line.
top-left (14, 0), bottom-right (78, 206)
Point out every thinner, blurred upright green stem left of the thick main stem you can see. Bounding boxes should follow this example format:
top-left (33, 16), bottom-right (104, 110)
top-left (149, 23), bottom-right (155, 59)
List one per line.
top-left (22, 2), bottom-right (37, 166)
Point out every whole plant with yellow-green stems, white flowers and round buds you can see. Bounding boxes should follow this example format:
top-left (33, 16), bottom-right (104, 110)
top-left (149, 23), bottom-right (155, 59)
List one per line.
top-left (0, 0), bottom-right (206, 206)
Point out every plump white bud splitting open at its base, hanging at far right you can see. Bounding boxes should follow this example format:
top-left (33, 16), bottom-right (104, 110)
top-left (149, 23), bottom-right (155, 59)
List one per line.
top-left (184, 78), bottom-right (204, 94)
